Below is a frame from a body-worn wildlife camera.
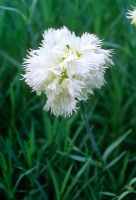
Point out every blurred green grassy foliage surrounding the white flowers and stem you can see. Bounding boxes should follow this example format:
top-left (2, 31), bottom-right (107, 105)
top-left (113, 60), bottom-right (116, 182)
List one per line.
top-left (0, 0), bottom-right (136, 200)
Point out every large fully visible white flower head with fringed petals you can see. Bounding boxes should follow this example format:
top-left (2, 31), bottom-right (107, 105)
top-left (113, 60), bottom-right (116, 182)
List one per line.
top-left (23, 27), bottom-right (112, 116)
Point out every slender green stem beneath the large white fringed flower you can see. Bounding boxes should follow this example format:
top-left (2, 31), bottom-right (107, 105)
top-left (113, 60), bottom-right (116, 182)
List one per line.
top-left (81, 103), bottom-right (101, 159)
